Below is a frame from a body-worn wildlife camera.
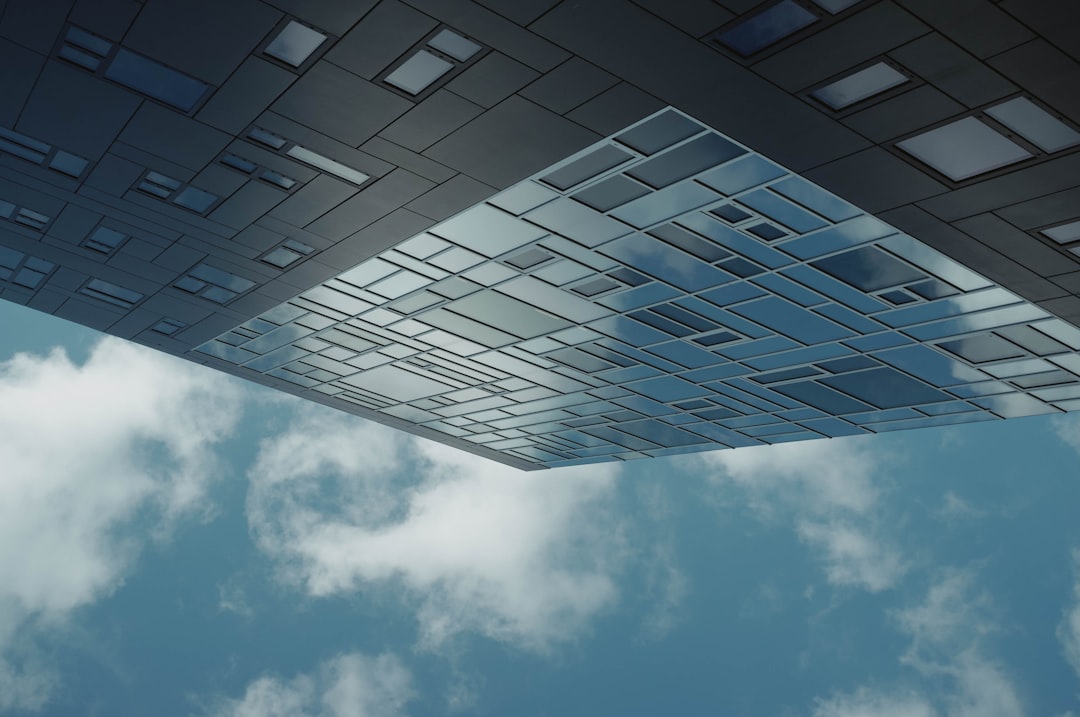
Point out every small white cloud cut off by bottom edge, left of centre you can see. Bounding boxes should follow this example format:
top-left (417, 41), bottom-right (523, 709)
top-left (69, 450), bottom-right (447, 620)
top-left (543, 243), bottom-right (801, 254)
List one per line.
top-left (211, 652), bottom-right (414, 717)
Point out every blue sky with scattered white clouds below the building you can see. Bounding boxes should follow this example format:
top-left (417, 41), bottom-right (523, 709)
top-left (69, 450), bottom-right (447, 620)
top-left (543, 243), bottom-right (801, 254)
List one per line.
top-left (0, 302), bottom-right (1080, 717)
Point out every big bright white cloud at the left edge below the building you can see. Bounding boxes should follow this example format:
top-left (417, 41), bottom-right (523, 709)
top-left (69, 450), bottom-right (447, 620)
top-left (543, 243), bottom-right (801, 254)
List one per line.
top-left (0, 339), bottom-right (245, 708)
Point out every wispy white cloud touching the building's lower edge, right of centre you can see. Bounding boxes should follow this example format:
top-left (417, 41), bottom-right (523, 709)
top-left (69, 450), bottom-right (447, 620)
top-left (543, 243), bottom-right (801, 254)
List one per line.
top-left (688, 438), bottom-right (907, 592)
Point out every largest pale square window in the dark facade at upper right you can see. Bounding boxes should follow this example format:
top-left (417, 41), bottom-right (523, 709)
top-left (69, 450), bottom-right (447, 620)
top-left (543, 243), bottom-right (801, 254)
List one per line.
top-left (896, 117), bottom-right (1031, 181)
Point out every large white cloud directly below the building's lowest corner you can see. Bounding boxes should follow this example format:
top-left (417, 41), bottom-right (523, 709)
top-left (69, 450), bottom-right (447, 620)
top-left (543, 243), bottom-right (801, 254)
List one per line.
top-left (247, 409), bottom-right (622, 650)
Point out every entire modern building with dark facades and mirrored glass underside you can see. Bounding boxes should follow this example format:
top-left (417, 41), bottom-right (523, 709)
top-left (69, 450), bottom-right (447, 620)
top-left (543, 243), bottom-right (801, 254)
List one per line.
top-left (0, 0), bottom-right (1080, 469)
